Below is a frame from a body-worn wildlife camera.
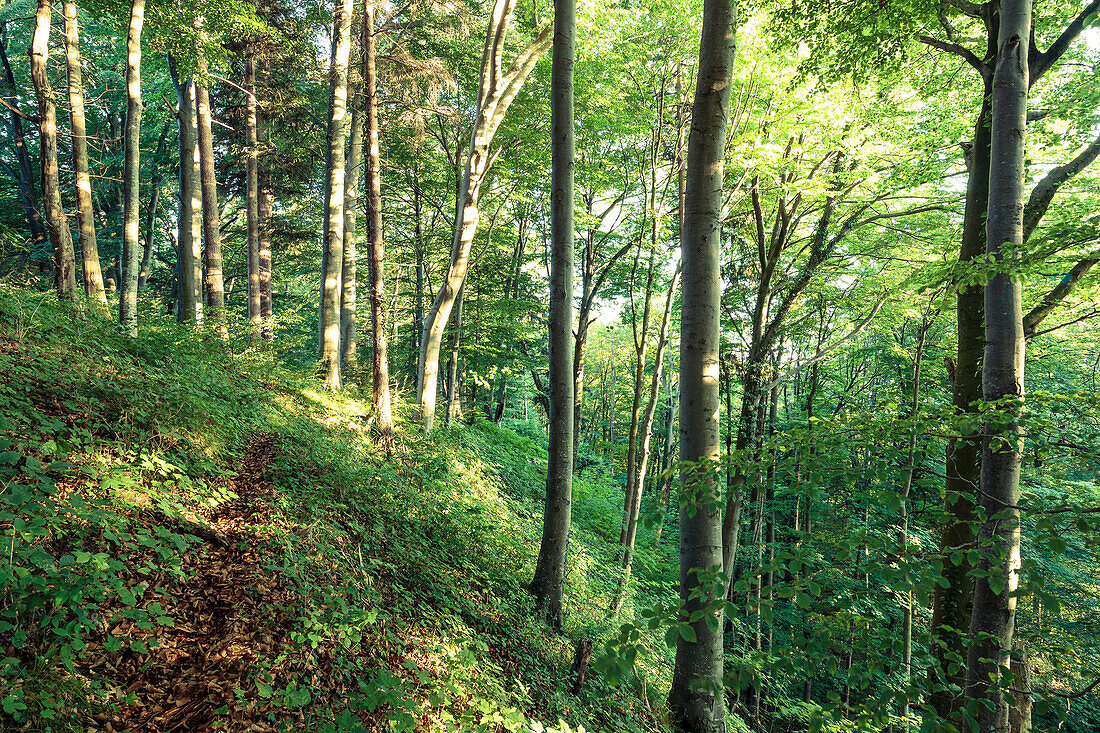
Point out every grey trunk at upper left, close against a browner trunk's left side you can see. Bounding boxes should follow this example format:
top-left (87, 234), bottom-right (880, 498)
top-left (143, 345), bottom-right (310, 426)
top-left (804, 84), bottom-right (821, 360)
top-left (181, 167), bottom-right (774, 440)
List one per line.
top-left (168, 56), bottom-right (204, 324)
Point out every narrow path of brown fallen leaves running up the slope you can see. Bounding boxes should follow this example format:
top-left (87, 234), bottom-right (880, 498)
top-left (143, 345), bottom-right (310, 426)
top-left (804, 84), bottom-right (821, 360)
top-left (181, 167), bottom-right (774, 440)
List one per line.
top-left (84, 435), bottom-right (319, 733)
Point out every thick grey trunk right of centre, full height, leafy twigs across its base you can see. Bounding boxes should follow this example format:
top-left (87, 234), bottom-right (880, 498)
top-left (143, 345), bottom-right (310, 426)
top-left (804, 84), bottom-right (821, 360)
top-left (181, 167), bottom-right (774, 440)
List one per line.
top-left (669, 0), bottom-right (736, 733)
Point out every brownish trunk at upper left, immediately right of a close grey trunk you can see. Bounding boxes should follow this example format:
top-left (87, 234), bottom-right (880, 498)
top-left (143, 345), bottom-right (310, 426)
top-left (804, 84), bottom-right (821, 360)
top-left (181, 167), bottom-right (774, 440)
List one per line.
top-left (195, 50), bottom-right (228, 337)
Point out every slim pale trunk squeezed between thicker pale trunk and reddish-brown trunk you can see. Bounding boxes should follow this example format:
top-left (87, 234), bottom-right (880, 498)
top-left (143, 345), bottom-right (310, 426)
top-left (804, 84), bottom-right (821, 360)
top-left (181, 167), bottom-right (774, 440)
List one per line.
top-left (340, 81), bottom-right (370, 381)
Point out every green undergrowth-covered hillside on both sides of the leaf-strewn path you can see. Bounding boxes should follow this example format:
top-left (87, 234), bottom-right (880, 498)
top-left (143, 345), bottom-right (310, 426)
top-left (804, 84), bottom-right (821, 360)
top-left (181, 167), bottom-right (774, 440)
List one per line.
top-left (0, 288), bottom-right (670, 731)
